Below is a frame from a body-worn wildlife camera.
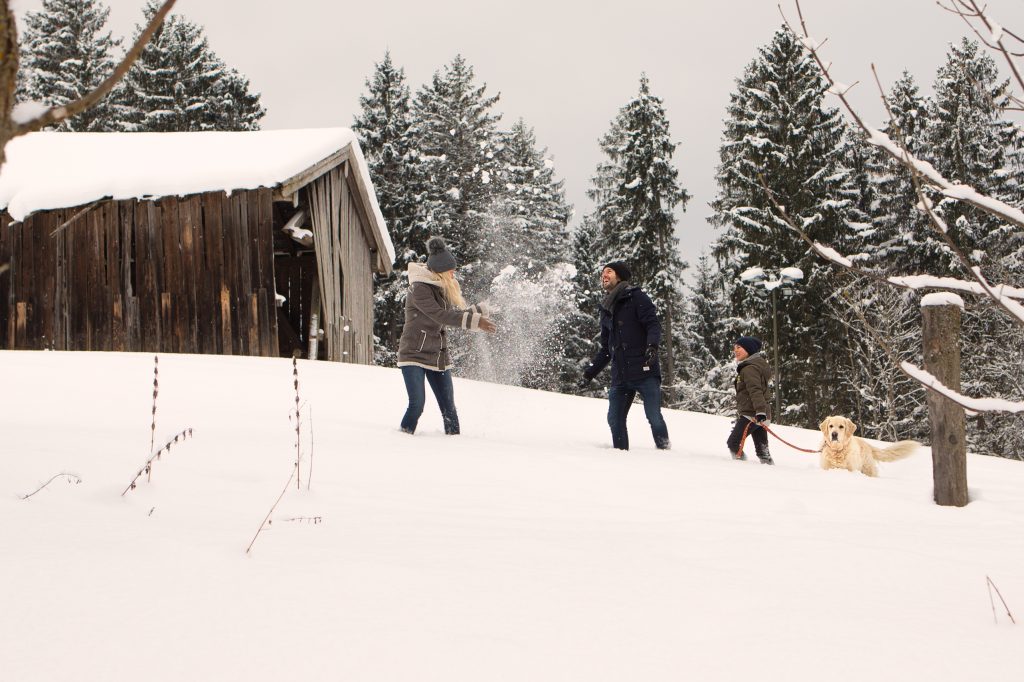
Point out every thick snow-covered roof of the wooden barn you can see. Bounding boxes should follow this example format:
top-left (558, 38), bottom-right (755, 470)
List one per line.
top-left (0, 128), bottom-right (394, 262)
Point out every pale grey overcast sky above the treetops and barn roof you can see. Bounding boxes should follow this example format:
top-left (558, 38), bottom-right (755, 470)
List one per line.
top-left (15, 0), bottom-right (1024, 263)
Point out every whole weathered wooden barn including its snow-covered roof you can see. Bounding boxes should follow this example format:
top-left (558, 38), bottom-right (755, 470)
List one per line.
top-left (0, 128), bottom-right (394, 364)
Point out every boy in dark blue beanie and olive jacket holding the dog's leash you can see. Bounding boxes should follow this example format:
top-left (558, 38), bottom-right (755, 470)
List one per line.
top-left (726, 336), bottom-right (775, 464)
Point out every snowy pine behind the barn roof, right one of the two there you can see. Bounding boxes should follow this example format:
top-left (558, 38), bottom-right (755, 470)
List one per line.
top-left (117, 0), bottom-right (265, 132)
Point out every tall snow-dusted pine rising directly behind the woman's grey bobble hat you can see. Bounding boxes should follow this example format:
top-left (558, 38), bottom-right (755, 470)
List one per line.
top-left (413, 55), bottom-right (501, 298)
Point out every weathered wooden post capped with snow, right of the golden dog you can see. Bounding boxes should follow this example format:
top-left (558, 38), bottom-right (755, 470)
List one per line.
top-left (921, 294), bottom-right (968, 507)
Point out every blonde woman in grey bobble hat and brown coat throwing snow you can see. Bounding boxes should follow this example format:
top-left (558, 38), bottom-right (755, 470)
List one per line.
top-left (398, 237), bottom-right (497, 435)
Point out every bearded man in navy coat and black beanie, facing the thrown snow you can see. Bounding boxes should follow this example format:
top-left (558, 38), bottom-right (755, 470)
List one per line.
top-left (580, 260), bottom-right (671, 450)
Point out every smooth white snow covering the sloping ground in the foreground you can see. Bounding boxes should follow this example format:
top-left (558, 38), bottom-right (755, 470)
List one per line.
top-left (0, 352), bottom-right (1024, 682)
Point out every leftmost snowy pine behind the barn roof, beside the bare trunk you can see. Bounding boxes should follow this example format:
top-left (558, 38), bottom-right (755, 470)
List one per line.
top-left (18, 0), bottom-right (120, 132)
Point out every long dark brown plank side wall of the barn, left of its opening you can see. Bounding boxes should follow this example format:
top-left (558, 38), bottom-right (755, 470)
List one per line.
top-left (0, 189), bottom-right (278, 355)
